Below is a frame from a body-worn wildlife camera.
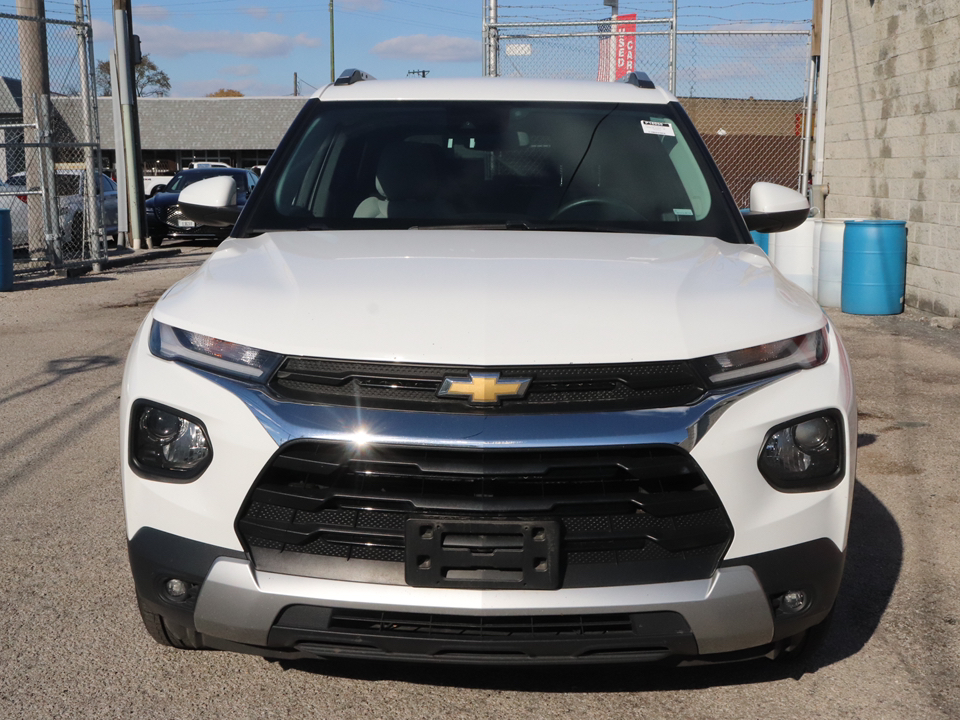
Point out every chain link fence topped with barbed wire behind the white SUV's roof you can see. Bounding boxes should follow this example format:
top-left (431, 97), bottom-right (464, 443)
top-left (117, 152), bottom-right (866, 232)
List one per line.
top-left (484, 16), bottom-right (810, 207)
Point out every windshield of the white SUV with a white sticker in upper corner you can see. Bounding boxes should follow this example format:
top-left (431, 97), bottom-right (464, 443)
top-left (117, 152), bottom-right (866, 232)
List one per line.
top-left (237, 101), bottom-right (745, 242)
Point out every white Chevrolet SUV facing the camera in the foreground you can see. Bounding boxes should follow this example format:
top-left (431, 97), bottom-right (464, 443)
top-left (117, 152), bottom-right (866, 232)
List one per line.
top-left (121, 72), bottom-right (857, 663)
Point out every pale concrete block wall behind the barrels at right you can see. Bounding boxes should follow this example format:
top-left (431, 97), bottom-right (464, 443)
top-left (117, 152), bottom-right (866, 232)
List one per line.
top-left (824, 0), bottom-right (960, 316)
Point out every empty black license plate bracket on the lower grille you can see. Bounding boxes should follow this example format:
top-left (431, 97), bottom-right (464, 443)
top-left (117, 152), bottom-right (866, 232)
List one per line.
top-left (405, 517), bottom-right (560, 590)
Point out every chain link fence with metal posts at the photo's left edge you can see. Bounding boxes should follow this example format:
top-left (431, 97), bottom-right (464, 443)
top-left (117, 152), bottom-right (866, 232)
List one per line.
top-left (0, 0), bottom-right (105, 273)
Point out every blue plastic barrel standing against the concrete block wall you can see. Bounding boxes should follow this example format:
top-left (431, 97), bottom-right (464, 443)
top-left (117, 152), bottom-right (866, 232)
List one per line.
top-left (840, 220), bottom-right (907, 315)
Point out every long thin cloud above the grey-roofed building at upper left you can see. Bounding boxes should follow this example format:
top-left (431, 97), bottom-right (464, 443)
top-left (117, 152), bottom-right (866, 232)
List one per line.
top-left (137, 25), bottom-right (320, 58)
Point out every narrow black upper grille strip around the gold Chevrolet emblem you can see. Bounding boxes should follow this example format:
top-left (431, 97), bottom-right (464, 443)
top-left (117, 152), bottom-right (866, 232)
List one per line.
top-left (270, 357), bottom-right (706, 413)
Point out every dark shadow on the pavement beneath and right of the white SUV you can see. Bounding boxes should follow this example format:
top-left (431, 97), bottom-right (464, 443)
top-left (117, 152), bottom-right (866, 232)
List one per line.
top-left (279, 482), bottom-right (903, 693)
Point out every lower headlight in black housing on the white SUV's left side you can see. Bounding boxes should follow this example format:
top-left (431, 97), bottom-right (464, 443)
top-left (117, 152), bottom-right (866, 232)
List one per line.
top-left (130, 401), bottom-right (213, 481)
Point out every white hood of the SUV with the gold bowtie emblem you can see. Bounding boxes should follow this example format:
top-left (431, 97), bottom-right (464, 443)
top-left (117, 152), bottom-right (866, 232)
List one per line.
top-left (154, 229), bottom-right (825, 366)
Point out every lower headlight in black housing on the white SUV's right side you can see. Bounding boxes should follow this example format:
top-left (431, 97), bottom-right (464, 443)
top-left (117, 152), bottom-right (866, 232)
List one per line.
top-left (757, 410), bottom-right (843, 492)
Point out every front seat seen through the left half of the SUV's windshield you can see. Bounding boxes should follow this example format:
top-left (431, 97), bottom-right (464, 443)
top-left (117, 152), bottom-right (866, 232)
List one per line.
top-left (353, 142), bottom-right (449, 218)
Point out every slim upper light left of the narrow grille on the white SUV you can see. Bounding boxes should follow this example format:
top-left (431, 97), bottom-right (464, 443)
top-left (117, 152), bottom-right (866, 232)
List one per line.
top-left (150, 320), bottom-right (283, 382)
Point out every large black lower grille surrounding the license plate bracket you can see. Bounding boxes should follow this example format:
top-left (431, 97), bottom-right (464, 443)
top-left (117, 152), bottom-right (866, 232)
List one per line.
top-left (237, 441), bottom-right (733, 587)
